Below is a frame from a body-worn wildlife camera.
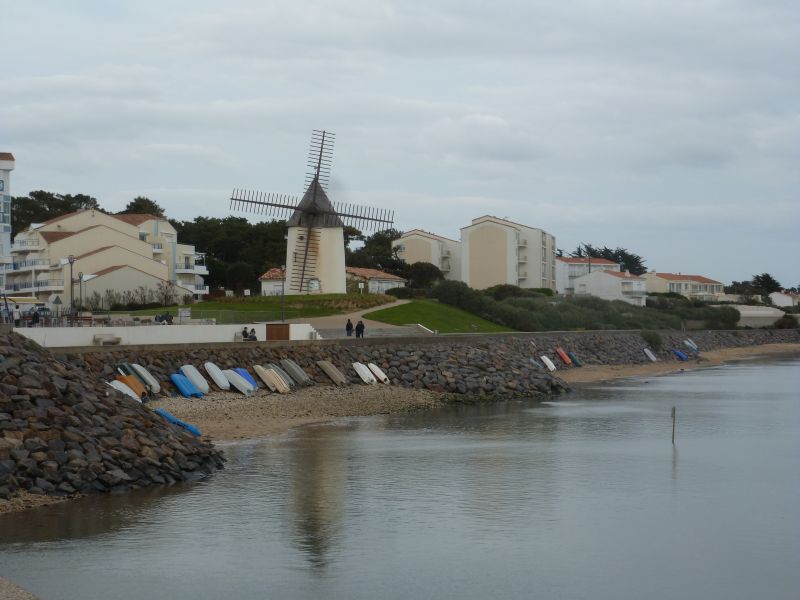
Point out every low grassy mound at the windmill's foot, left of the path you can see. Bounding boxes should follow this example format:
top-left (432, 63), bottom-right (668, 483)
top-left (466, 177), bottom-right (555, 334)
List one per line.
top-left (108, 294), bottom-right (395, 324)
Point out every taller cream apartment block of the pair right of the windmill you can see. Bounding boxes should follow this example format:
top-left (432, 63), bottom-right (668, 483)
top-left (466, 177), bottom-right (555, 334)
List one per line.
top-left (461, 215), bottom-right (556, 291)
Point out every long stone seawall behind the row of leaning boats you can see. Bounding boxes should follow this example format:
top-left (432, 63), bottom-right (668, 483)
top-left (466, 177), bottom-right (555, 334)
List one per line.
top-left (53, 330), bottom-right (800, 396)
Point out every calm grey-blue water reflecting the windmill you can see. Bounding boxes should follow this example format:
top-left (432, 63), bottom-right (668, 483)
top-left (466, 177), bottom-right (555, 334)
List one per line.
top-left (0, 360), bottom-right (800, 600)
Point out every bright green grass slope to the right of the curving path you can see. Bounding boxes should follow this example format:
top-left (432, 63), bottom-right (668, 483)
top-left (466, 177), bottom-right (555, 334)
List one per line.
top-left (364, 300), bottom-right (514, 333)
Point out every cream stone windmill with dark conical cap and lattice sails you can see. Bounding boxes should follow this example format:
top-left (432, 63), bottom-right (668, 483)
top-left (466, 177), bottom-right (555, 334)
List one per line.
top-left (230, 129), bottom-right (394, 294)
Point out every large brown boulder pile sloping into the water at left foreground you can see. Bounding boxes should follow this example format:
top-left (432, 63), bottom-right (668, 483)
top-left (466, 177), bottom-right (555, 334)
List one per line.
top-left (0, 332), bottom-right (223, 499)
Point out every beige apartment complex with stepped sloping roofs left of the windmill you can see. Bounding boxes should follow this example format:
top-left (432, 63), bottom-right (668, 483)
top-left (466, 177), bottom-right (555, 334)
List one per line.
top-left (5, 210), bottom-right (208, 306)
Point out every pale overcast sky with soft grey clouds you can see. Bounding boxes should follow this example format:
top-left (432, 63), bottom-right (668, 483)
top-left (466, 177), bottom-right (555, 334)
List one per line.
top-left (0, 0), bottom-right (800, 287)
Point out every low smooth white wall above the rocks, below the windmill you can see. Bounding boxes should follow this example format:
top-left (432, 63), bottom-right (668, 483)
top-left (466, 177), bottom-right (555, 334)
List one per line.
top-left (14, 323), bottom-right (316, 348)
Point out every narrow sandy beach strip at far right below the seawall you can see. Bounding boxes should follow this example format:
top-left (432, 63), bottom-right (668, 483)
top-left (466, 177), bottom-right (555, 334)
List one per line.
top-left (557, 344), bottom-right (800, 385)
